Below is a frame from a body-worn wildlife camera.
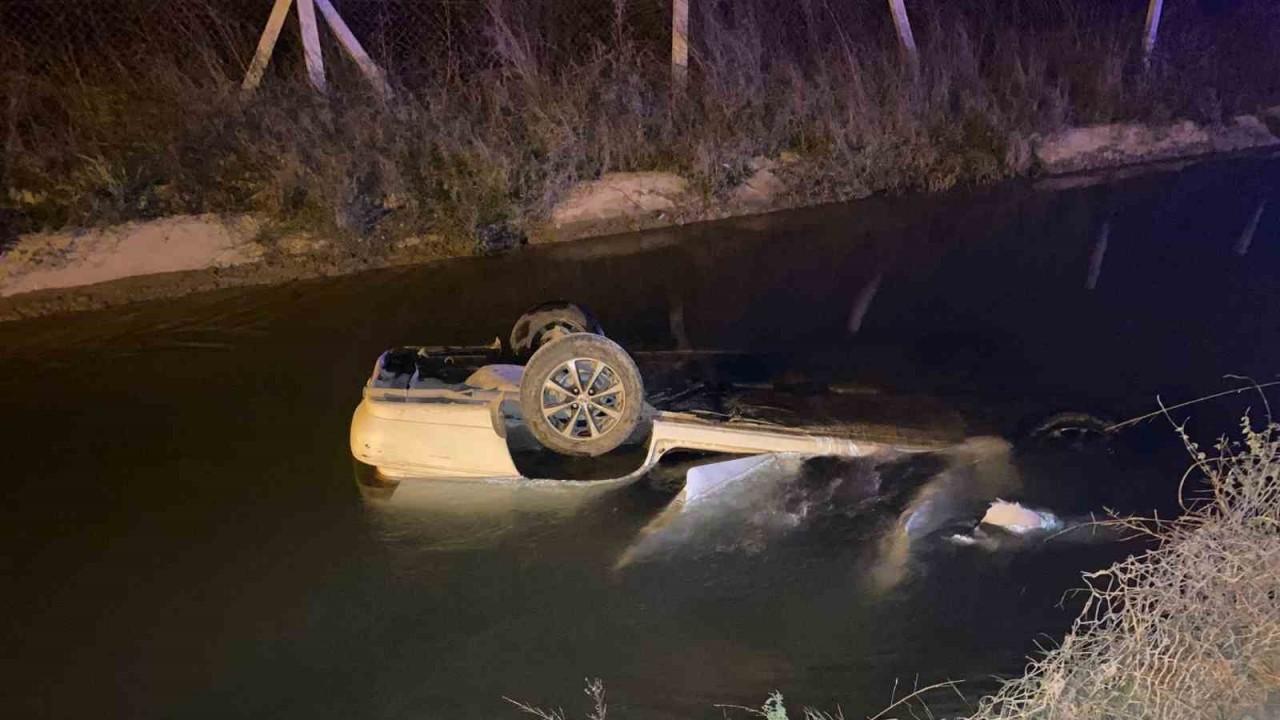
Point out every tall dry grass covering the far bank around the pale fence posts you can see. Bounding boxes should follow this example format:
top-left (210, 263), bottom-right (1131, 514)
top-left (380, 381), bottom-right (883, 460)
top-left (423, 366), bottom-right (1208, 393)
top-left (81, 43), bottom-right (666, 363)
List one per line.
top-left (0, 0), bottom-right (1280, 252)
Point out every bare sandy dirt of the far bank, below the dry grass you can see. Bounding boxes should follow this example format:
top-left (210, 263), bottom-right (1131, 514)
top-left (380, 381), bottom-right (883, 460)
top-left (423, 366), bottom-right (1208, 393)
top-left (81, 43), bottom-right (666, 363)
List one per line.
top-left (0, 108), bottom-right (1280, 320)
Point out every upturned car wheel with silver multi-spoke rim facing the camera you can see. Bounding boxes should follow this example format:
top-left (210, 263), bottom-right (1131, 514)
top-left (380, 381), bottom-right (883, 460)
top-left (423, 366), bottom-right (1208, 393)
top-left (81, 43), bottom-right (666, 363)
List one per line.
top-left (520, 333), bottom-right (644, 457)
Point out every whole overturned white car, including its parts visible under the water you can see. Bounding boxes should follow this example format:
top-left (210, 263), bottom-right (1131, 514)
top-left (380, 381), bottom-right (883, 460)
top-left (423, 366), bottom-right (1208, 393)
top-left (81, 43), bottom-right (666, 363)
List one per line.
top-left (351, 304), bottom-right (1131, 571)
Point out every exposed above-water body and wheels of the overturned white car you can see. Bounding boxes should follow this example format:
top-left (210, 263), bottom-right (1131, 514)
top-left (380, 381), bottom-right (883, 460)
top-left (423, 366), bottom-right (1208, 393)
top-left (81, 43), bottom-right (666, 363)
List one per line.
top-left (351, 304), bottom-right (931, 482)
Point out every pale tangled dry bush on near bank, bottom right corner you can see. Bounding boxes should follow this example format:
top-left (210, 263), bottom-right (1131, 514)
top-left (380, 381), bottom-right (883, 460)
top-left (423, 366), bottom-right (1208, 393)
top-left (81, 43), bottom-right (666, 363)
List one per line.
top-left (974, 419), bottom-right (1280, 720)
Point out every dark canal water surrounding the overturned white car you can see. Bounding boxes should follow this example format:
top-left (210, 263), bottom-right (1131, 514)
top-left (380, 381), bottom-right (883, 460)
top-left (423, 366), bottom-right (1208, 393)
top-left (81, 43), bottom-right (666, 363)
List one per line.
top-left (0, 151), bottom-right (1280, 719)
